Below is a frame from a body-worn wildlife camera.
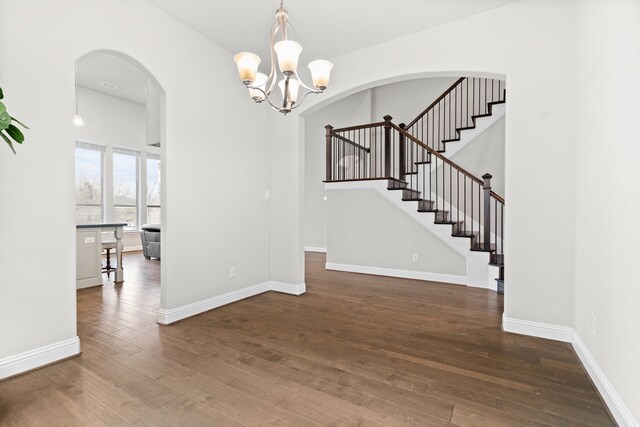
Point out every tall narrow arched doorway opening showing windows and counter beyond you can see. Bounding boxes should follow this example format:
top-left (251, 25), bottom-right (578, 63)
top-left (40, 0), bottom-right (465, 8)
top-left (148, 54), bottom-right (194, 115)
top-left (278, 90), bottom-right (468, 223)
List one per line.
top-left (74, 50), bottom-right (166, 320)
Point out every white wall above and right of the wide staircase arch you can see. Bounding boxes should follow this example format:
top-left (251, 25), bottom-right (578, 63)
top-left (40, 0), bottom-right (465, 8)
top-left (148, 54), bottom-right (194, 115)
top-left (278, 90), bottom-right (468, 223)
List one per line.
top-left (296, 0), bottom-right (577, 327)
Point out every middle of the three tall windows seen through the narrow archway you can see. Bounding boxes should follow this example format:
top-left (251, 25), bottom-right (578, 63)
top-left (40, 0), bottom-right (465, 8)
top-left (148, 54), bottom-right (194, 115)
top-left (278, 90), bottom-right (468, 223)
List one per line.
top-left (112, 148), bottom-right (140, 230)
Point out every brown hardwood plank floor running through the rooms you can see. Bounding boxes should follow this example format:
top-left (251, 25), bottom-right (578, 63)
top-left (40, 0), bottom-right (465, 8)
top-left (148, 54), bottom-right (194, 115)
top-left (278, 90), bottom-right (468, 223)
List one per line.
top-left (0, 253), bottom-right (615, 426)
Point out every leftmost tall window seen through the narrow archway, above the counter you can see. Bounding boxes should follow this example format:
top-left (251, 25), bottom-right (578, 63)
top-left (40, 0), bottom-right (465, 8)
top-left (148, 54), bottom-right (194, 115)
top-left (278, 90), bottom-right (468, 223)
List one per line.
top-left (76, 142), bottom-right (105, 224)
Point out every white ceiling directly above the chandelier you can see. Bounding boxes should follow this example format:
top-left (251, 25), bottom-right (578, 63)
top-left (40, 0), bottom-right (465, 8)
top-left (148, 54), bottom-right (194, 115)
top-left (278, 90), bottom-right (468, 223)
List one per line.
top-left (147, 0), bottom-right (517, 63)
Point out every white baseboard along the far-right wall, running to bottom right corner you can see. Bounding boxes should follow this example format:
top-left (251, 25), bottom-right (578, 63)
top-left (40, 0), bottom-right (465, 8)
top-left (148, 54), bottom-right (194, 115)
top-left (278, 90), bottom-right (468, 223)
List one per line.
top-left (572, 331), bottom-right (638, 427)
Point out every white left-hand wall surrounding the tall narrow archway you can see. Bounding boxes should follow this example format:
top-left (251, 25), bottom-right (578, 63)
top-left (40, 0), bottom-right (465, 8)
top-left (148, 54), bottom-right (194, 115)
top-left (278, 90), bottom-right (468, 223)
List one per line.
top-left (0, 0), bottom-right (268, 359)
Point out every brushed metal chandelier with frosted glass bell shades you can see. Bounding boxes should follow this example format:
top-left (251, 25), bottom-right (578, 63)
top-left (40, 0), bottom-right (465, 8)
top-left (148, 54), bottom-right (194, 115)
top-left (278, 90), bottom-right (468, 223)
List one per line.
top-left (233, 1), bottom-right (333, 115)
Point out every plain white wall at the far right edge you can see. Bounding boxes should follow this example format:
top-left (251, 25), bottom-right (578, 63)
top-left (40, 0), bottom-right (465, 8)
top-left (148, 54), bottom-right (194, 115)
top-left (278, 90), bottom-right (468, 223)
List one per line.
top-left (574, 0), bottom-right (640, 425)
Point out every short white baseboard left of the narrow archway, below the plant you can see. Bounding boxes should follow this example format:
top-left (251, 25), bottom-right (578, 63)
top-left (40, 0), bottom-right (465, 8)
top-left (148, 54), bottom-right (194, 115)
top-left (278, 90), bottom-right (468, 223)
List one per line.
top-left (0, 337), bottom-right (80, 380)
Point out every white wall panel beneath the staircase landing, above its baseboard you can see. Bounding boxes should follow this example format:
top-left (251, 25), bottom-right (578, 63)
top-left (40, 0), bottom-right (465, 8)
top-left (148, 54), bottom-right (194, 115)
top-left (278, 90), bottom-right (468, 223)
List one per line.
top-left (327, 190), bottom-right (466, 277)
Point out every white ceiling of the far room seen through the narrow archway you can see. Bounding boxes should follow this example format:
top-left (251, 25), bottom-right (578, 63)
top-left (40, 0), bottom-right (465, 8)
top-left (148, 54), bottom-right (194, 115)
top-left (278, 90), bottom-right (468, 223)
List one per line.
top-left (78, 52), bottom-right (147, 105)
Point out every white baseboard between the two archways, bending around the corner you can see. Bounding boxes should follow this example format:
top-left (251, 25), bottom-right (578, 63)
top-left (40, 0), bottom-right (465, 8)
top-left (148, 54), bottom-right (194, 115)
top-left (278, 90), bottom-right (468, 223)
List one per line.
top-left (158, 282), bottom-right (306, 325)
